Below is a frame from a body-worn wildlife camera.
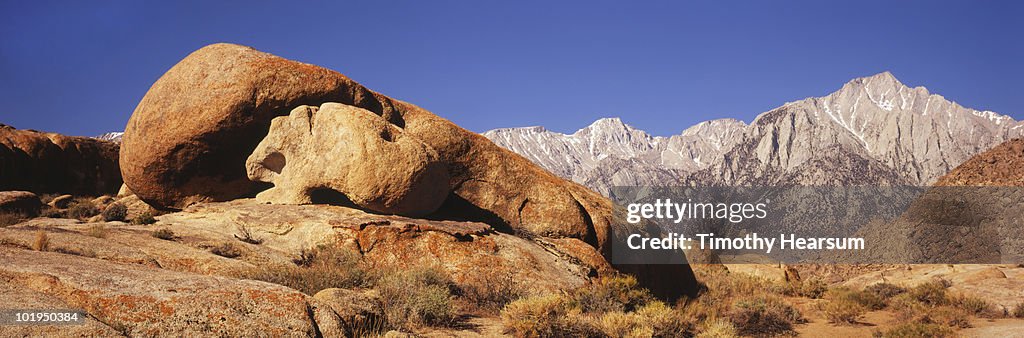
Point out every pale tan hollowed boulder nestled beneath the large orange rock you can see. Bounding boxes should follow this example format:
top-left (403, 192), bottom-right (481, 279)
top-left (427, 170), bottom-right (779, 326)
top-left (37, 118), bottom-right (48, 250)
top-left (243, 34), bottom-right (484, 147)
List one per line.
top-left (246, 103), bottom-right (449, 216)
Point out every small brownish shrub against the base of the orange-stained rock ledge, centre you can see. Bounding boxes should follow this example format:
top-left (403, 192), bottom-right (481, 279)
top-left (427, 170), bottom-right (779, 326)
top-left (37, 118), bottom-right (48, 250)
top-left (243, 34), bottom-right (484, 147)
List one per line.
top-left (459, 269), bottom-right (523, 314)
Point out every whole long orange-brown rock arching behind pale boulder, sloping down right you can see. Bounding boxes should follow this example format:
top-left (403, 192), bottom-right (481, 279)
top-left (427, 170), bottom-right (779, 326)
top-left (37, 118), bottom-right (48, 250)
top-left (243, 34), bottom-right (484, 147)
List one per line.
top-left (121, 44), bottom-right (696, 299)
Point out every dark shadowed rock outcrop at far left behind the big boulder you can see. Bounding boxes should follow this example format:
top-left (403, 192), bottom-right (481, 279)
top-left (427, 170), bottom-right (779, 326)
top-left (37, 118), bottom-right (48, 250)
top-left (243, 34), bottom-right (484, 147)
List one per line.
top-left (0, 124), bottom-right (121, 196)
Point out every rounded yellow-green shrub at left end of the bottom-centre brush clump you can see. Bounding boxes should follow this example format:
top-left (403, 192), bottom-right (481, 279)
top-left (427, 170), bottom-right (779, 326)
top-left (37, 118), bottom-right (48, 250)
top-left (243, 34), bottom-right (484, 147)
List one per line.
top-left (501, 294), bottom-right (597, 337)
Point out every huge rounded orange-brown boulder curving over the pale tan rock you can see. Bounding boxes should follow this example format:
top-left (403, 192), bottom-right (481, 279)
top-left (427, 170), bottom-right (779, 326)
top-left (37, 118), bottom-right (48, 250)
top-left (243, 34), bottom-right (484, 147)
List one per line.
top-left (121, 44), bottom-right (381, 208)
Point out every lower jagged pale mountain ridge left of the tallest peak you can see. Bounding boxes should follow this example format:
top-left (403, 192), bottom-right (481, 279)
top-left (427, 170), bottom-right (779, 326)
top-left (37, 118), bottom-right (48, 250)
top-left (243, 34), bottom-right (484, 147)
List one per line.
top-left (483, 118), bottom-right (745, 194)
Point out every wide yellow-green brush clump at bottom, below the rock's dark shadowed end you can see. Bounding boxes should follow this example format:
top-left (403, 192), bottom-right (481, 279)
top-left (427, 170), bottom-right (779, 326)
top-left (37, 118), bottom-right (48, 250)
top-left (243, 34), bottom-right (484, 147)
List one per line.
top-left (501, 276), bottom-right (694, 337)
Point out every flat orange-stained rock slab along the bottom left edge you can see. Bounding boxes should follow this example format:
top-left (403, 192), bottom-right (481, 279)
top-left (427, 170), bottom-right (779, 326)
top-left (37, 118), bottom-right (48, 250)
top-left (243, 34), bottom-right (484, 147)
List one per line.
top-left (0, 248), bottom-right (344, 337)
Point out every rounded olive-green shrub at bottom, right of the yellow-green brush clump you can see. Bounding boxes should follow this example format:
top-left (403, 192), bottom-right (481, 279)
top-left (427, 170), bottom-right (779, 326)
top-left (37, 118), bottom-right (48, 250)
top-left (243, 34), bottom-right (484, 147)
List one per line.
top-left (730, 296), bottom-right (804, 336)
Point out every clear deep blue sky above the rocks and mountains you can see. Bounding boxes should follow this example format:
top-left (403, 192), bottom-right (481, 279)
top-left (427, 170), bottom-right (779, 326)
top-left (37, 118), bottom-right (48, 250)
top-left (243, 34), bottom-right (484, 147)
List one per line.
top-left (0, 0), bottom-right (1024, 135)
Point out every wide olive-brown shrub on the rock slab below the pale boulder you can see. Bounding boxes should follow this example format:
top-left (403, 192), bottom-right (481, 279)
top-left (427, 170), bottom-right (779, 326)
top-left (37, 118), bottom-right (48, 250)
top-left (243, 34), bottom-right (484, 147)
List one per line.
top-left (241, 242), bottom-right (369, 295)
